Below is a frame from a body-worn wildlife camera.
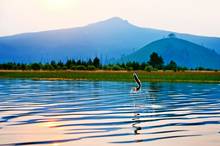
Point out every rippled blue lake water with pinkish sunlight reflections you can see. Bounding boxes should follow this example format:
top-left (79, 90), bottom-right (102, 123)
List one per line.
top-left (0, 79), bottom-right (220, 146)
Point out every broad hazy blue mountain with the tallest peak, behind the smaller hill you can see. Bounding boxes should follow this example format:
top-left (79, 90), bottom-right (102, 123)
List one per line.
top-left (0, 17), bottom-right (220, 62)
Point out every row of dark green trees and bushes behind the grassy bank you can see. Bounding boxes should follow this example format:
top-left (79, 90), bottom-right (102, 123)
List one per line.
top-left (0, 52), bottom-right (213, 72)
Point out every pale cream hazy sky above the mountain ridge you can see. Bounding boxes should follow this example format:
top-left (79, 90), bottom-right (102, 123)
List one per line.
top-left (0, 0), bottom-right (220, 37)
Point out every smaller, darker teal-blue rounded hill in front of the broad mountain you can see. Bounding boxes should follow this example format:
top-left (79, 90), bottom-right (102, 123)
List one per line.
top-left (120, 37), bottom-right (220, 69)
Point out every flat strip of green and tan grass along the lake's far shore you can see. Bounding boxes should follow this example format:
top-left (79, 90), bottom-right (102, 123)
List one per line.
top-left (0, 70), bottom-right (220, 83)
